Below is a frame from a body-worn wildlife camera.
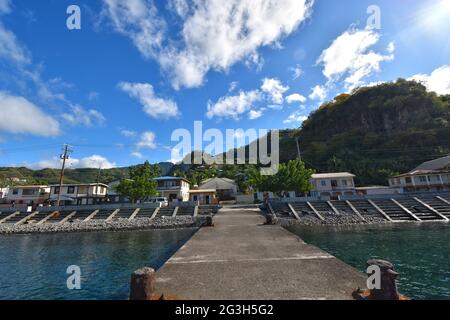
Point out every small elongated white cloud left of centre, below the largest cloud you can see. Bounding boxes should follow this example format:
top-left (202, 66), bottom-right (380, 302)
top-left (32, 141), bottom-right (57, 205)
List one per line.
top-left (119, 82), bottom-right (180, 119)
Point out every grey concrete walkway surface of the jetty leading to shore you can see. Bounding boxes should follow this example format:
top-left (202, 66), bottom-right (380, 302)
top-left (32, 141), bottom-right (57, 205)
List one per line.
top-left (156, 207), bottom-right (367, 300)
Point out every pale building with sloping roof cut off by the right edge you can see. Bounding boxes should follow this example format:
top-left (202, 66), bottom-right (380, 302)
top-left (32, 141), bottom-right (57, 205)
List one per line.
top-left (389, 156), bottom-right (450, 193)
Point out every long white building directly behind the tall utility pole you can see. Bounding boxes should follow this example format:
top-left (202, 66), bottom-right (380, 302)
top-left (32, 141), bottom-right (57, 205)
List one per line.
top-left (50, 183), bottom-right (108, 205)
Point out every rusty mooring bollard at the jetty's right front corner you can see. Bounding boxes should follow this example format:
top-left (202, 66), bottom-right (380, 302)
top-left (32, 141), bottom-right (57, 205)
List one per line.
top-left (367, 259), bottom-right (400, 300)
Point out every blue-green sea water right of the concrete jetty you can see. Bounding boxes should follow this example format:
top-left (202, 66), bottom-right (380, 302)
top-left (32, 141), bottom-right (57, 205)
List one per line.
top-left (289, 223), bottom-right (450, 299)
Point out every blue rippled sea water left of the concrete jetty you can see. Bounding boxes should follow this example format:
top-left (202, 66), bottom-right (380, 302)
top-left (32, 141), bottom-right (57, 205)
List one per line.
top-left (0, 229), bottom-right (196, 300)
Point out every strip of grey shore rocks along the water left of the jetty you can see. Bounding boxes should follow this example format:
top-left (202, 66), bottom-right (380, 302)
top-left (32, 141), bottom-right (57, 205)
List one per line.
top-left (0, 216), bottom-right (206, 236)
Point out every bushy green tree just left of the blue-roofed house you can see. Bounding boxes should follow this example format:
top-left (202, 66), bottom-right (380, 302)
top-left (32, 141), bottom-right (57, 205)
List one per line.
top-left (116, 161), bottom-right (161, 203)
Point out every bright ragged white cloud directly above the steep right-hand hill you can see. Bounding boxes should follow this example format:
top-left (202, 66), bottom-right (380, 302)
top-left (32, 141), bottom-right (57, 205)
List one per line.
top-left (317, 29), bottom-right (395, 89)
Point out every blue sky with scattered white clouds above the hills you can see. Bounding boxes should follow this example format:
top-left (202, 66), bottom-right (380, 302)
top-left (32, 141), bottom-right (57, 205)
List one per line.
top-left (0, 0), bottom-right (450, 168)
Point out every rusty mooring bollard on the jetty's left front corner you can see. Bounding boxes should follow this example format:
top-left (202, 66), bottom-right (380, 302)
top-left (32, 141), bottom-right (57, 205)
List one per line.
top-left (130, 267), bottom-right (156, 300)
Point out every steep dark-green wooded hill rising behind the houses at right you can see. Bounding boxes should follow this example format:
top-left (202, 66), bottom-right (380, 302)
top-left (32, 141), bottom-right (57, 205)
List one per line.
top-left (296, 79), bottom-right (450, 185)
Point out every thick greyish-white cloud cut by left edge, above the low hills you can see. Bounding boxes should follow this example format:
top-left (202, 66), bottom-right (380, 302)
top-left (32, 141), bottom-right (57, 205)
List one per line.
top-left (0, 91), bottom-right (60, 137)
